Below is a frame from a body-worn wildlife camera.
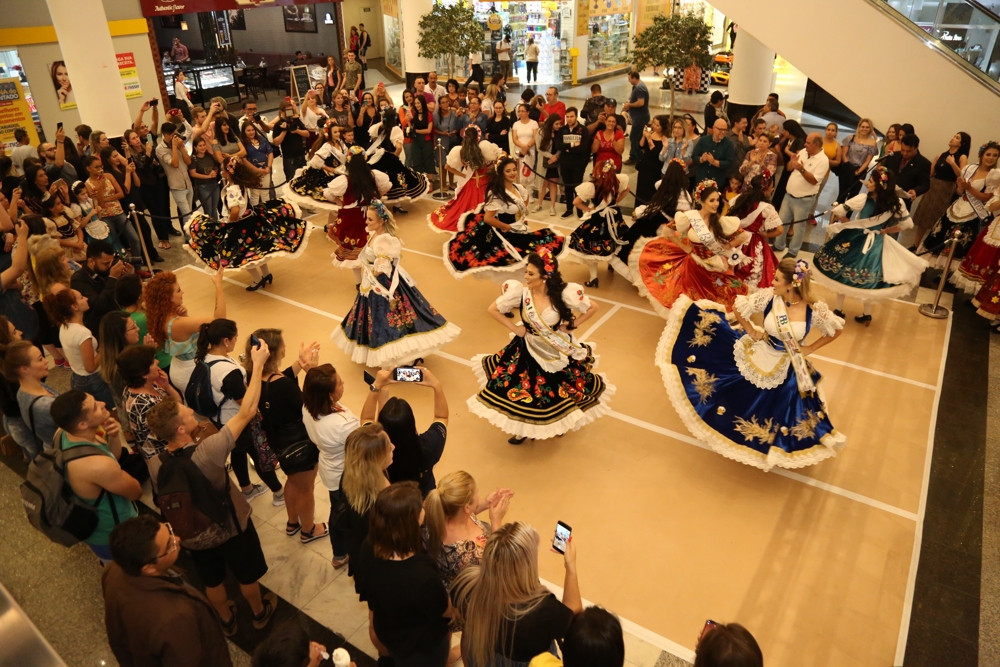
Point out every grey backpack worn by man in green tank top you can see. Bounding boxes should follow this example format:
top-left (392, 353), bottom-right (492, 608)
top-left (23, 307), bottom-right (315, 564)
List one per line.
top-left (21, 429), bottom-right (119, 547)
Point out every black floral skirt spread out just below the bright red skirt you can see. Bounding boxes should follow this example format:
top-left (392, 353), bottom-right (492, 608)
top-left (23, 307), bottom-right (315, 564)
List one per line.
top-left (444, 206), bottom-right (566, 280)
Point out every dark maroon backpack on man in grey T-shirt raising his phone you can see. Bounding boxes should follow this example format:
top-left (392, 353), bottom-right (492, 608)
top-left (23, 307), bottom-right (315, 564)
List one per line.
top-left (156, 447), bottom-right (240, 551)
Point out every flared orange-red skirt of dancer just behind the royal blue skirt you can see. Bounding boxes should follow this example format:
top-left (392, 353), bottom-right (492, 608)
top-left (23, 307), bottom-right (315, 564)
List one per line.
top-left (628, 236), bottom-right (747, 317)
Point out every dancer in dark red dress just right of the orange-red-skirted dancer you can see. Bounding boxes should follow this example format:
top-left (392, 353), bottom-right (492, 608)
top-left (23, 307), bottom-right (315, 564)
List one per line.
top-left (729, 171), bottom-right (785, 292)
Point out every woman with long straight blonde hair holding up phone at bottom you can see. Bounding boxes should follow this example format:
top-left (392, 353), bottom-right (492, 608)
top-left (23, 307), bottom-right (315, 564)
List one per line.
top-left (462, 522), bottom-right (583, 667)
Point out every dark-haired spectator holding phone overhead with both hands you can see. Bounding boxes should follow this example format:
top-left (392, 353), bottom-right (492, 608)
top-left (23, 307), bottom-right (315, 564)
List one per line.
top-left (361, 366), bottom-right (448, 496)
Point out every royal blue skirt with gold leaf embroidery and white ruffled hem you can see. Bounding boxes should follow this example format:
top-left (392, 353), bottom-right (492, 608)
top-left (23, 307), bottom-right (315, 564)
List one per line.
top-left (655, 296), bottom-right (847, 471)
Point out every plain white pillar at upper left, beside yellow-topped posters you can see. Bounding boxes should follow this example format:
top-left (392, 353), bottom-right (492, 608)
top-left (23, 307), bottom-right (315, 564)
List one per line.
top-left (46, 0), bottom-right (132, 136)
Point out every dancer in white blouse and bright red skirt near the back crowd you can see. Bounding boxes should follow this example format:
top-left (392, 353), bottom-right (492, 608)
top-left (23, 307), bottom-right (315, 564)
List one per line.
top-left (427, 125), bottom-right (501, 234)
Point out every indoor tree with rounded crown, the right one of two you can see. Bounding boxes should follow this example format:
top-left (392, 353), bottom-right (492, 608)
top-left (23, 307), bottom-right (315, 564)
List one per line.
top-left (632, 13), bottom-right (712, 122)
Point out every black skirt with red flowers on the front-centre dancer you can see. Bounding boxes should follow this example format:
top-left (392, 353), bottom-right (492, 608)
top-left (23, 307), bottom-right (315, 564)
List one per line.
top-left (466, 336), bottom-right (615, 440)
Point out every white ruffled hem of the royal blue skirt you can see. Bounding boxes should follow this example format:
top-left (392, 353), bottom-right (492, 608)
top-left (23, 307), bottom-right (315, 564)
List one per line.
top-left (654, 294), bottom-right (847, 472)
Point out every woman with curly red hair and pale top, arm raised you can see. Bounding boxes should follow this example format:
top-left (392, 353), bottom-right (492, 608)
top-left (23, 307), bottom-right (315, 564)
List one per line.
top-left (144, 267), bottom-right (226, 396)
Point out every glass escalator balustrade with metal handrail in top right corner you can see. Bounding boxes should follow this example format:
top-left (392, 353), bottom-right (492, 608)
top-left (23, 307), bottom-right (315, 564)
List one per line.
top-left (880, 0), bottom-right (1000, 95)
